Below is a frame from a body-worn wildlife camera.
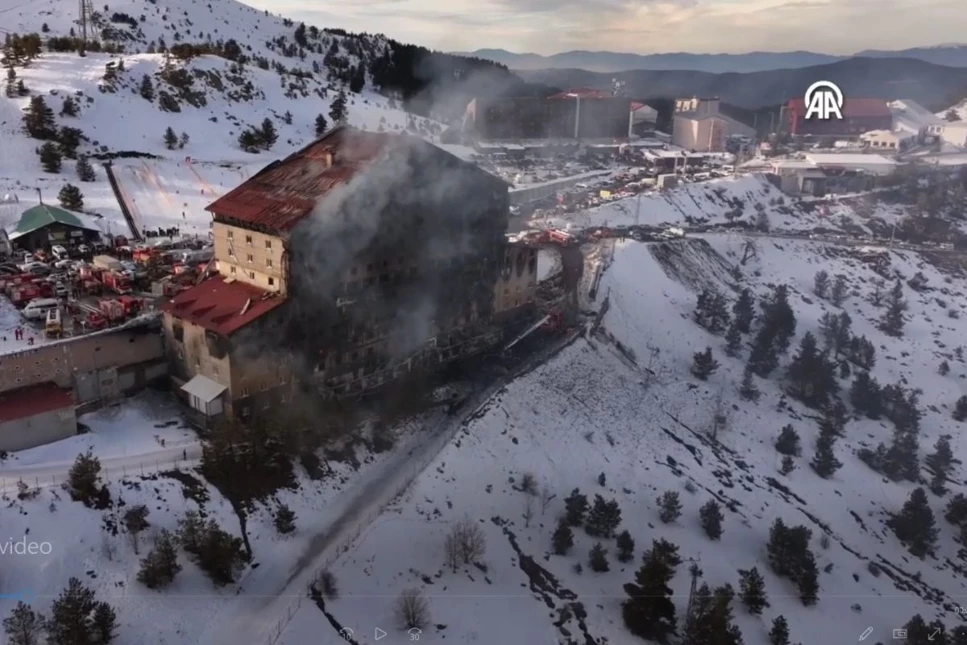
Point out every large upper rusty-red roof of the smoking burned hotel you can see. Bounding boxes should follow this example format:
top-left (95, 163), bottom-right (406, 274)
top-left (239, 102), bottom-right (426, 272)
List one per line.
top-left (206, 126), bottom-right (509, 232)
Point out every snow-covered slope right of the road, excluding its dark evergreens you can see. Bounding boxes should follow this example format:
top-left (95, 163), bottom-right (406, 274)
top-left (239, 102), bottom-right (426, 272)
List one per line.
top-left (274, 235), bottom-right (967, 645)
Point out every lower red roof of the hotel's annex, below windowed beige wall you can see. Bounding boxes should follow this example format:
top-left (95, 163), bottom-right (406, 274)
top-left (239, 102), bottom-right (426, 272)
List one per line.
top-left (161, 275), bottom-right (285, 336)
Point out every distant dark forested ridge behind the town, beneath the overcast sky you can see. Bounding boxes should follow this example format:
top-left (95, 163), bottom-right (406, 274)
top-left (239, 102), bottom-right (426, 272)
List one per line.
top-left (519, 58), bottom-right (967, 110)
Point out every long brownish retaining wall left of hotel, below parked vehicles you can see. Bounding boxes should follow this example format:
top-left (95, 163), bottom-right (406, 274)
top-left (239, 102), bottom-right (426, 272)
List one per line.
top-left (0, 330), bottom-right (164, 392)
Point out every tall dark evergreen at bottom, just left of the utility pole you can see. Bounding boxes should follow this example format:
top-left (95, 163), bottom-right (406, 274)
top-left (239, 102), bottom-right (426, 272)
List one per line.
top-left (621, 540), bottom-right (681, 643)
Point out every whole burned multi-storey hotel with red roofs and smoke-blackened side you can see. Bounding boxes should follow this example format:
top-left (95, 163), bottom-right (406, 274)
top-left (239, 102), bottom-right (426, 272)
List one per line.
top-left (163, 127), bottom-right (537, 420)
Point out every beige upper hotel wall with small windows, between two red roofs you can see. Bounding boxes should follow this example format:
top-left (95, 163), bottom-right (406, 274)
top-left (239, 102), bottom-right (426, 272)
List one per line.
top-left (212, 221), bottom-right (287, 293)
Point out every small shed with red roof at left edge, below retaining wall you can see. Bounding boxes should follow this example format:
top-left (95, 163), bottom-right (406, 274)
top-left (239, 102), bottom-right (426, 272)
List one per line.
top-left (0, 383), bottom-right (77, 451)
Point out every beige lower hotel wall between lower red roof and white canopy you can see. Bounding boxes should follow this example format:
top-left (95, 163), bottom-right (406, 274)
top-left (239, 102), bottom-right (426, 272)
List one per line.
top-left (163, 313), bottom-right (232, 393)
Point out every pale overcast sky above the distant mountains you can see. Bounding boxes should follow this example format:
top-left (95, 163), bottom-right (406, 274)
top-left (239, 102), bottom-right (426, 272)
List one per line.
top-left (243, 0), bottom-right (967, 55)
